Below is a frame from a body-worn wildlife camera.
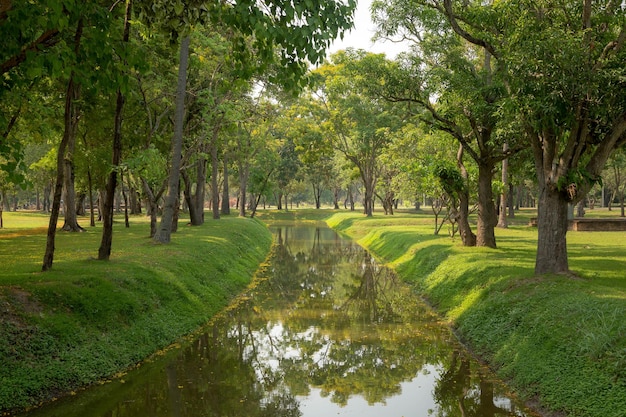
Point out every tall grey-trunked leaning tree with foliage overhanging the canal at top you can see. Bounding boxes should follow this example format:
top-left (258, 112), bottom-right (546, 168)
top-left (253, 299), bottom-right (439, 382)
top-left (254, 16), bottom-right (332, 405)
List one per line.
top-left (139, 0), bottom-right (356, 243)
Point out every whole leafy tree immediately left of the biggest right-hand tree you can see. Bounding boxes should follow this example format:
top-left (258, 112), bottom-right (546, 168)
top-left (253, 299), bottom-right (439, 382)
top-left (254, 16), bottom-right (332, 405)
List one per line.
top-left (372, 1), bottom-right (525, 247)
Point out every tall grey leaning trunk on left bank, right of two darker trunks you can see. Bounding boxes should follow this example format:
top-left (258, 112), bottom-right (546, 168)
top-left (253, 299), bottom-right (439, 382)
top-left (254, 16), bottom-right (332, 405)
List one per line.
top-left (153, 36), bottom-right (191, 243)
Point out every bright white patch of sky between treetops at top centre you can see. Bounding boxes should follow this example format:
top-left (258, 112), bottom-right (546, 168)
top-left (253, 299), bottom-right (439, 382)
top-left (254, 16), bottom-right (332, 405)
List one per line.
top-left (328, 0), bottom-right (406, 58)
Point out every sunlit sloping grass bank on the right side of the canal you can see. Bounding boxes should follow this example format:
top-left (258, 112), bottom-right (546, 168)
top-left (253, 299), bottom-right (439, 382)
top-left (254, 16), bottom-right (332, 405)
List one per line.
top-left (327, 213), bottom-right (626, 417)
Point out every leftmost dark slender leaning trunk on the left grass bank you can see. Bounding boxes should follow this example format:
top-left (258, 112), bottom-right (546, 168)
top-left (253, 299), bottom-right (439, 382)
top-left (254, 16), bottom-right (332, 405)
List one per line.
top-left (41, 19), bottom-right (83, 271)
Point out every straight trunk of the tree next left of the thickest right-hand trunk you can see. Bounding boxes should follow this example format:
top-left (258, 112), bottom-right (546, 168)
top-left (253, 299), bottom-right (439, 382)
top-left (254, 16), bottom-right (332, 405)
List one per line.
top-left (476, 163), bottom-right (498, 248)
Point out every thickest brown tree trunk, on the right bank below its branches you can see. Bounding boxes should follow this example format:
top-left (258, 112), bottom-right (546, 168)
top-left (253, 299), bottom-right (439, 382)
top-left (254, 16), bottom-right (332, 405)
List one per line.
top-left (535, 182), bottom-right (569, 275)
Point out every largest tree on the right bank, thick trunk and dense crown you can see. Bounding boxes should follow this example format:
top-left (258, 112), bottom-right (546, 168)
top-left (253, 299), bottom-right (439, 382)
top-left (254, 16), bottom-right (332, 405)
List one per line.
top-left (378, 0), bottom-right (626, 274)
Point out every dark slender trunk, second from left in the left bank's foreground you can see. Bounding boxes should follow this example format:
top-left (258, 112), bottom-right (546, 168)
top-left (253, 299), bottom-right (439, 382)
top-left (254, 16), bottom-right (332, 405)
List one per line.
top-left (98, 1), bottom-right (132, 260)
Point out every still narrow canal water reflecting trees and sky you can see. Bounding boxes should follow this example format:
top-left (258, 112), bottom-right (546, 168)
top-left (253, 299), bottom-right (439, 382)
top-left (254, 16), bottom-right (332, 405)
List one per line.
top-left (19, 226), bottom-right (535, 417)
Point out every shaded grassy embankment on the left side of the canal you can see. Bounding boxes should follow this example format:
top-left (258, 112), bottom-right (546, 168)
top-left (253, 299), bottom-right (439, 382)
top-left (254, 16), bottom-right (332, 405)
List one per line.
top-left (0, 212), bottom-right (271, 413)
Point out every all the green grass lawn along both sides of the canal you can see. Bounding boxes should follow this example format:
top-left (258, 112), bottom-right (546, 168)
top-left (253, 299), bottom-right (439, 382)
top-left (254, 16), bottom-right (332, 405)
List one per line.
top-left (0, 209), bottom-right (626, 417)
